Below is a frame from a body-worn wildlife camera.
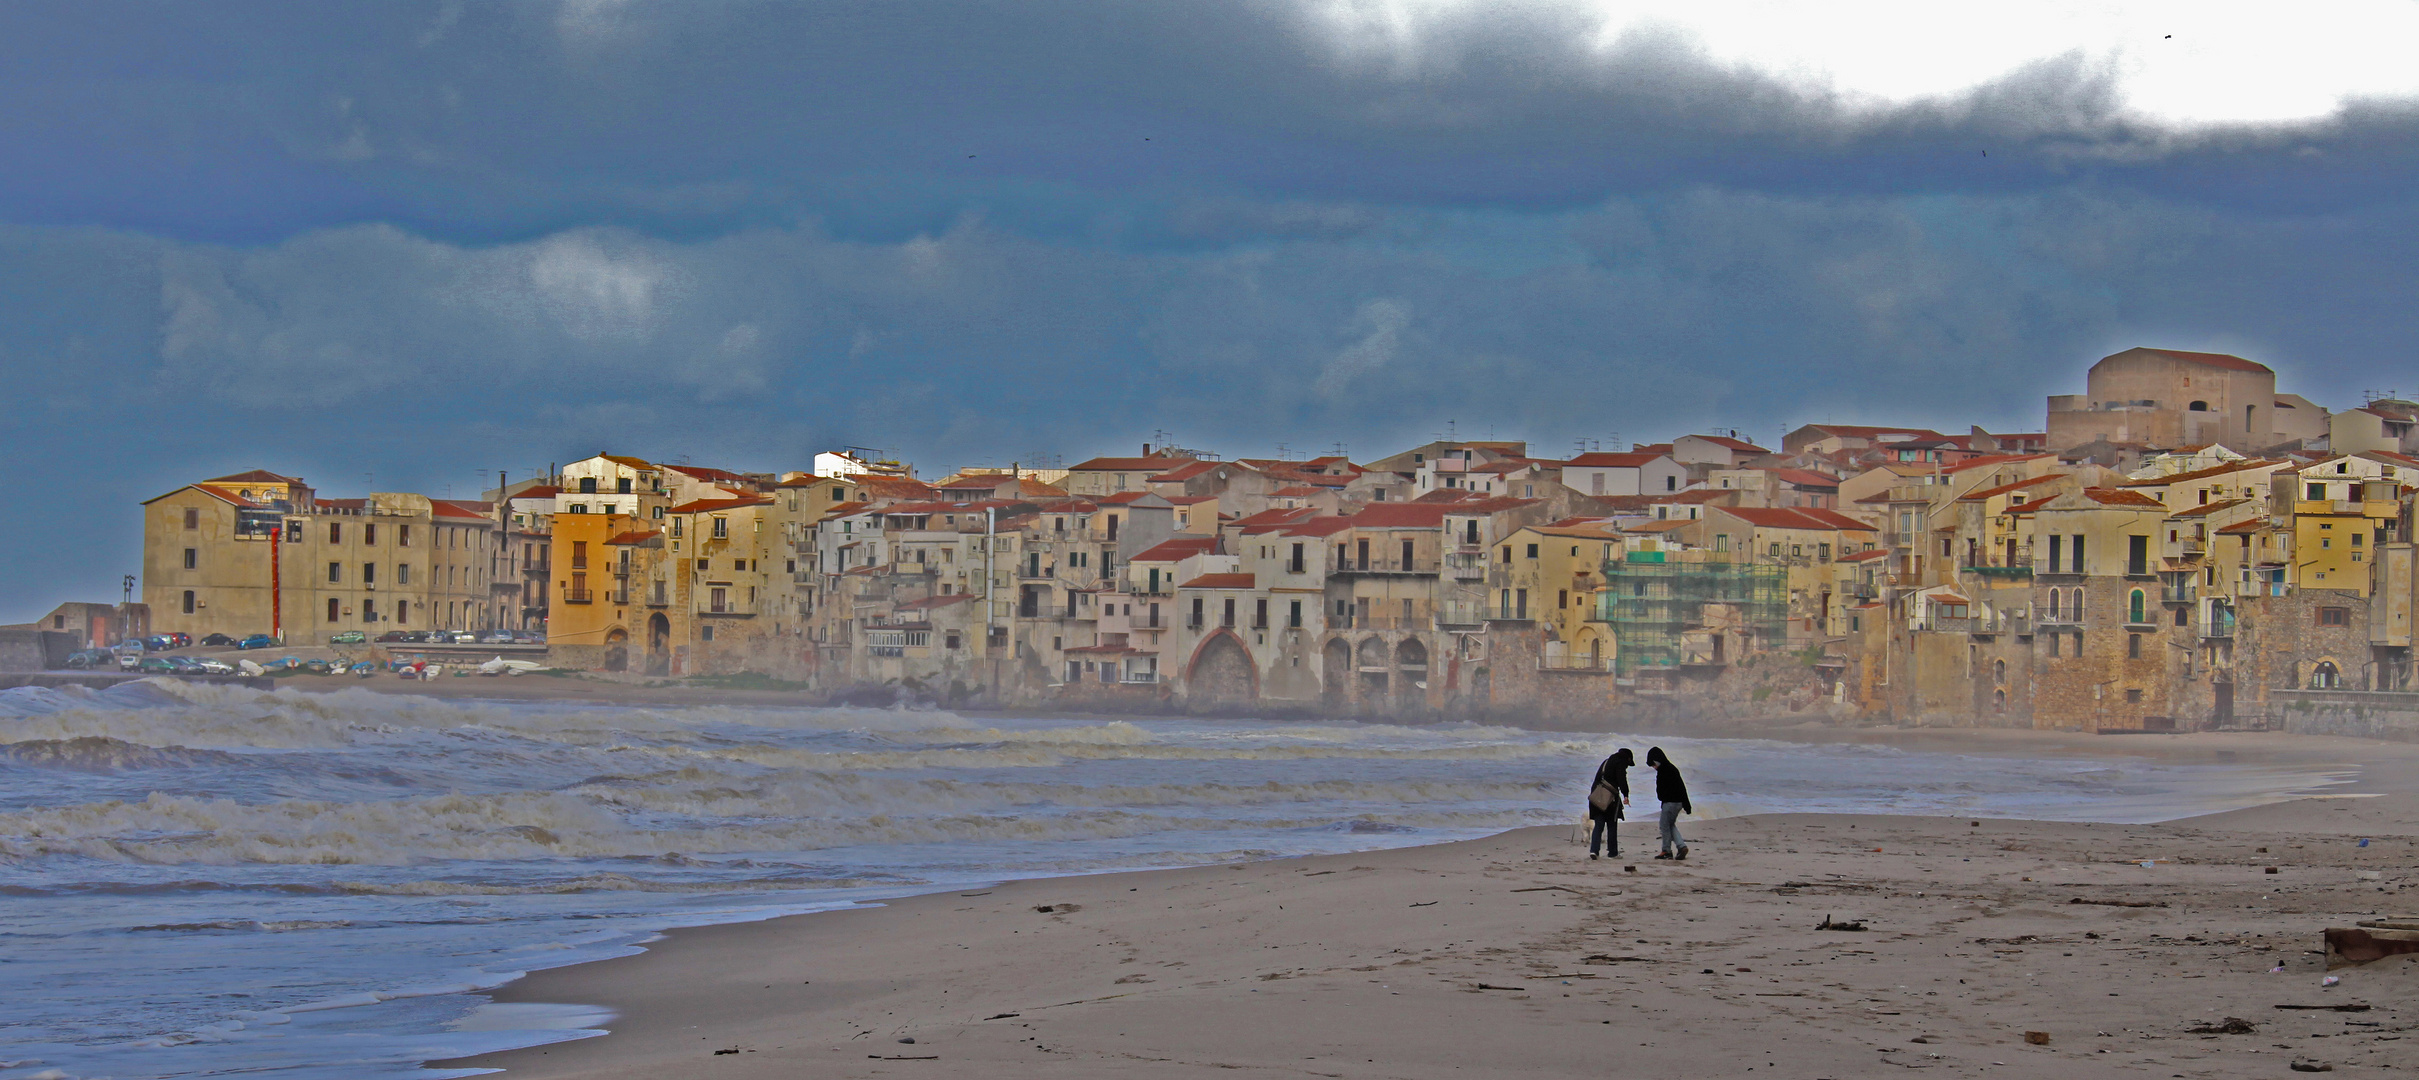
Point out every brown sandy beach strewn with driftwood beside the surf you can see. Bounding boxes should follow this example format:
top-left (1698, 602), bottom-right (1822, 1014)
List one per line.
top-left (448, 731), bottom-right (2419, 1080)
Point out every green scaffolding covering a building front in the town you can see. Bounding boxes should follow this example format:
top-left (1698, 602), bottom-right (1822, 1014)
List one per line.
top-left (1597, 552), bottom-right (1790, 676)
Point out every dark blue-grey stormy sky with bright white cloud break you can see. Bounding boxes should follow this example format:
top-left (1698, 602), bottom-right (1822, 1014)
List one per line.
top-left (0, 0), bottom-right (2419, 620)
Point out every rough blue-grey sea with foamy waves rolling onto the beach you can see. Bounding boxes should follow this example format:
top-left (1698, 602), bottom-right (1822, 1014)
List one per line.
top-left (0, 676), bottom-right (2346, 1080)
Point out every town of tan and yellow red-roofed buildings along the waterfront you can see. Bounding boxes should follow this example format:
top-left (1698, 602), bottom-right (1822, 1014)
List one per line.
top-left (108, 349), bottom-right (2419, 731)
